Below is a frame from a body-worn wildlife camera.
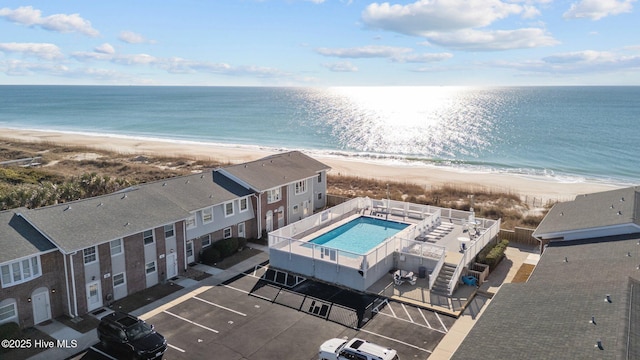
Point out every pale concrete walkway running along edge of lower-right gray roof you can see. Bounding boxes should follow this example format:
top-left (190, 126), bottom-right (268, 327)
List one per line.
top-left (429, 244), bottom-right (540, 360)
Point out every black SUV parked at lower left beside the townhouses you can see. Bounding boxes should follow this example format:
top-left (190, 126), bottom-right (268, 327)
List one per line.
top-left (98, 311), bottom-right (167, 359)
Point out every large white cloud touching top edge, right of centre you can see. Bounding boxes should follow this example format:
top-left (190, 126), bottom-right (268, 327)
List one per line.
top-left (362, 0), bottom-right (532, 36)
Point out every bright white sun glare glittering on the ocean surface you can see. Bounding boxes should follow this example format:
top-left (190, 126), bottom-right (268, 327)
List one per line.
top-left (325, 87), bottom-right (496, 158)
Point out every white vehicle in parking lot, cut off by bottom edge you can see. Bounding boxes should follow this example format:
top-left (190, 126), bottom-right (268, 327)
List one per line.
top-left (319, 338), bottom-right (398, 360)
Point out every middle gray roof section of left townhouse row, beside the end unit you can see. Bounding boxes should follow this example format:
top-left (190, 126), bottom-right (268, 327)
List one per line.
top-left (139, 171), bottom-right (251, 211)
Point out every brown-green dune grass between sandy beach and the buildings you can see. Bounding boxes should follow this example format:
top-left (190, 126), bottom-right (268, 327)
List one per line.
top-left (0, 140), bottom-right (549, 229)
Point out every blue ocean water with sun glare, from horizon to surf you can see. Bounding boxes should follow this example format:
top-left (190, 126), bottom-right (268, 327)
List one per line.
top-left (0, 85), bottom-right (640, 184)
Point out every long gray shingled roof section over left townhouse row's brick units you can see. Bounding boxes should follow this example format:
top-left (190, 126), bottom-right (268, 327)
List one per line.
top-left (23, 188), bottom-right (190, 253)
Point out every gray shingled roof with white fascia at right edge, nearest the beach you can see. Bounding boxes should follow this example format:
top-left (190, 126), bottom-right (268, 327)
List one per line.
top-left (533, 187), bottom-right (640, 238)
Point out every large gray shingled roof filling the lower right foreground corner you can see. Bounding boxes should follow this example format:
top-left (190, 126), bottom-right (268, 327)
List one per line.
top-left (453, 234), bottom-right (640, 359)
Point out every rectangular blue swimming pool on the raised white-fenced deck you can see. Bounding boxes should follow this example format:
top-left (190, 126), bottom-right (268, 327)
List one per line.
top-left (309, 216), bottom-right (409, 255)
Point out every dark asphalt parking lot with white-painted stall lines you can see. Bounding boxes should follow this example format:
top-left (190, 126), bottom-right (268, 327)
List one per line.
top-left (76, 266), bottom-right (455, 360)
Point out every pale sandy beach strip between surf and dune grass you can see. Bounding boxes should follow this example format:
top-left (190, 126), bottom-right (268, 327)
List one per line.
top-left (0, 129), bottom-right (617, 203)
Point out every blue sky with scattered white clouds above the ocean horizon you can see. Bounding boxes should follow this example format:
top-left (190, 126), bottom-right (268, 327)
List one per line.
top-left (0, 0), bottom-right (640, 86)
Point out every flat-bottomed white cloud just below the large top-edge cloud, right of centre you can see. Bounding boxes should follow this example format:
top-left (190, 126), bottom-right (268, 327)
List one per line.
top-left (427, 28), bottom-right (559, 51)
